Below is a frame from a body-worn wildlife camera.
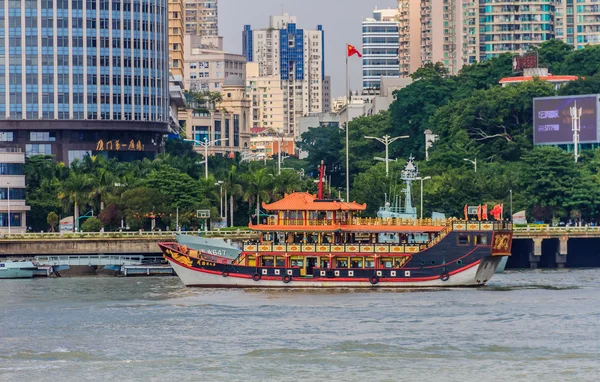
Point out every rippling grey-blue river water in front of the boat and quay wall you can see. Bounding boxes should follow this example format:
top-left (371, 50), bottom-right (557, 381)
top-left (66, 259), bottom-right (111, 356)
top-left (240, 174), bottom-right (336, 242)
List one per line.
top-left (0, 269), bottom-right (600, 382)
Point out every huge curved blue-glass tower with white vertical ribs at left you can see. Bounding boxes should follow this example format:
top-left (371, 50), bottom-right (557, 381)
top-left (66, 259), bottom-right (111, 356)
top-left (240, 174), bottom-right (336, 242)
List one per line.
top-left (0, 0), bottom-right (169, 162)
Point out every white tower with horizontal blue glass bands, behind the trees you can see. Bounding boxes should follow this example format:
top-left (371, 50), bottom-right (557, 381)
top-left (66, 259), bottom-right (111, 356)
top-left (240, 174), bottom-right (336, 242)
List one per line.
top-left (362, 9), bottom-right (400, 89)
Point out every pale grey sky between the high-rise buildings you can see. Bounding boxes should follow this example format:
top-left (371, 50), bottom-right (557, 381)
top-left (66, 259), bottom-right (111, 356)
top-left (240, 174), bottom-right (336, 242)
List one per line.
top-left (219, 0), bottom-right (397, 97)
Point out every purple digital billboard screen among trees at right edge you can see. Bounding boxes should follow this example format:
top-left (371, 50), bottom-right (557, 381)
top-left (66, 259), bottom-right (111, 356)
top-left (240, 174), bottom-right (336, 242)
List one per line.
top-left (533, 95), bottom-right (598, 145)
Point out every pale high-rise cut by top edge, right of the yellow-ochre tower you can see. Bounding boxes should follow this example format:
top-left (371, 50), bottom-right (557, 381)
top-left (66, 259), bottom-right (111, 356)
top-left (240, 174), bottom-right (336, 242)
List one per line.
top-left (184, 0), bottom-right (219, 36)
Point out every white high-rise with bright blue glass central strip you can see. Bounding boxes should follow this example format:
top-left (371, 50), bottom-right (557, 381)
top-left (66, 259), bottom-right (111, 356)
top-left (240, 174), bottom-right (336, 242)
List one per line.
top-left (242, 14), bottom-right (325, 137)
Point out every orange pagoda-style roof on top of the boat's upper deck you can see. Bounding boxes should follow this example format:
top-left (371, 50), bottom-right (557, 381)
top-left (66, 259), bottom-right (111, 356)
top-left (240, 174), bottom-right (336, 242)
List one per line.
top-left (262, 192), bottom-right (367, 211)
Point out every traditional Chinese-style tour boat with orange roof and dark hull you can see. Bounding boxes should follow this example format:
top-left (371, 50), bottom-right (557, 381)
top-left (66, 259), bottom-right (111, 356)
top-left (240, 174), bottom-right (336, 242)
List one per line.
top-left (159, 192), bottom-right (512, 288)
